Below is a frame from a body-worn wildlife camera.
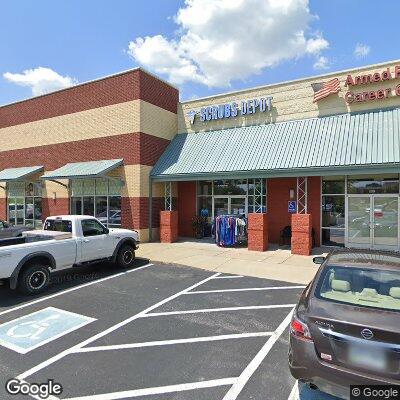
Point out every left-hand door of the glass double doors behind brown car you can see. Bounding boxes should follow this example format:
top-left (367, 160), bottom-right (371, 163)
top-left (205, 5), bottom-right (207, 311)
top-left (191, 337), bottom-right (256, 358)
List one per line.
top-left (346, 196), bottom-right (371, 249)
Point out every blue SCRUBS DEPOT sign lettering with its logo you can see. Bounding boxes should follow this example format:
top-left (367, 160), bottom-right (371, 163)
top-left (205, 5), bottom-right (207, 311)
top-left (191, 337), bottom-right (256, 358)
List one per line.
top-left (187, 97), bottom-right (272, 124)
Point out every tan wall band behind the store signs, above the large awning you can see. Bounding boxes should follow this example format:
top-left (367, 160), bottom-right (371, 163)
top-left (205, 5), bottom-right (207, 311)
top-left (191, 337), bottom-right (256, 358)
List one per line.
top-left (178, 60), bottom-right (400, 133)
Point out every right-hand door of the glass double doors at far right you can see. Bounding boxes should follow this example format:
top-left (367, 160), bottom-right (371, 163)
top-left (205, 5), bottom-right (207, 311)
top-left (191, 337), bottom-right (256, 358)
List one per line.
top-left (371, 196), bottom-right (399, 250)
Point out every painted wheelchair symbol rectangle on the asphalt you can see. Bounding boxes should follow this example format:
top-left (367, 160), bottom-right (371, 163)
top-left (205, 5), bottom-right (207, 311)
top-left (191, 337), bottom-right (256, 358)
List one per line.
top-left (0, 307), bottom-right (95, 354)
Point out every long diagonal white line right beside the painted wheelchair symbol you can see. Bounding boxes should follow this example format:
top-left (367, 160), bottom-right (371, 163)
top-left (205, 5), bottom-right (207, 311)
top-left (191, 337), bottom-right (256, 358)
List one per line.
top-left (17, 272), bottom-right (220, 379)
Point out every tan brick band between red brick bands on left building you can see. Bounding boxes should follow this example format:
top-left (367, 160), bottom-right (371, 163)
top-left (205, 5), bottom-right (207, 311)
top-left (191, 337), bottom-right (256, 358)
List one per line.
top-left (0, 100), bottom-right (177, 151)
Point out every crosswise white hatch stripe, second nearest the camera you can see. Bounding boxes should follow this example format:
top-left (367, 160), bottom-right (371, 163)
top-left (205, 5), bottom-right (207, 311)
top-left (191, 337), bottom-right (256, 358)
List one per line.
top-left (74, 332), bottom-right (273, 353)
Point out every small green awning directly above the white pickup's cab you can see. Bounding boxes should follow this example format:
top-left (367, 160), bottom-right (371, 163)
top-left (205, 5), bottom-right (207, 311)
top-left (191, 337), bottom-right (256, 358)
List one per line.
top-left (41, 158), bottom-right (124, 180)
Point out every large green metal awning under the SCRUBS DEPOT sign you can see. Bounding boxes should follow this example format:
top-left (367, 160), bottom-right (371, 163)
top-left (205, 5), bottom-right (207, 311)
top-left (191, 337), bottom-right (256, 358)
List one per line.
top-left (151, 109), bottom-right (400, 181)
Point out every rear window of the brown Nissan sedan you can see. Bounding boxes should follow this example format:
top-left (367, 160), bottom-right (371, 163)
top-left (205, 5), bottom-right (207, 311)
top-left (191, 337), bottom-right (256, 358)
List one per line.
top-left (316, 266), bottom-right (400, 311)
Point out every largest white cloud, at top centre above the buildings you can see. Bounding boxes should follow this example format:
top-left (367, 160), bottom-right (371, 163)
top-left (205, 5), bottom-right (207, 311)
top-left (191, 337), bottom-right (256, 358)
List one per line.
top-left (127, 0), bottom-right (329, 87)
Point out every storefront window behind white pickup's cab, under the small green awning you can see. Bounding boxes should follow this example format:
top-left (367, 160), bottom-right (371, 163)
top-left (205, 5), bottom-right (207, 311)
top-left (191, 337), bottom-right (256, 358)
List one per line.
top-left (70, 179), bottom-right (121, 227)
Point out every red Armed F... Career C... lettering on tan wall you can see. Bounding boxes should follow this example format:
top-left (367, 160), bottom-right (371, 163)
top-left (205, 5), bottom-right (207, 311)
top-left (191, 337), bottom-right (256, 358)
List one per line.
top-left (344, 65), bottom-right (400, 104)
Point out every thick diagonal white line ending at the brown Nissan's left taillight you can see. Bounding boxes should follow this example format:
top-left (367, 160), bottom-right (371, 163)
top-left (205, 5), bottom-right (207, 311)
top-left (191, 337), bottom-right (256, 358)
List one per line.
top-left (223, 310), bottom-right (293, 400)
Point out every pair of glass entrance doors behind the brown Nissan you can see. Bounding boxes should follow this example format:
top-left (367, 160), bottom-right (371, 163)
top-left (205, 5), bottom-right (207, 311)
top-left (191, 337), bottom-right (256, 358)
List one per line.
top-left (346, 195), bottom-right (399, 250)
